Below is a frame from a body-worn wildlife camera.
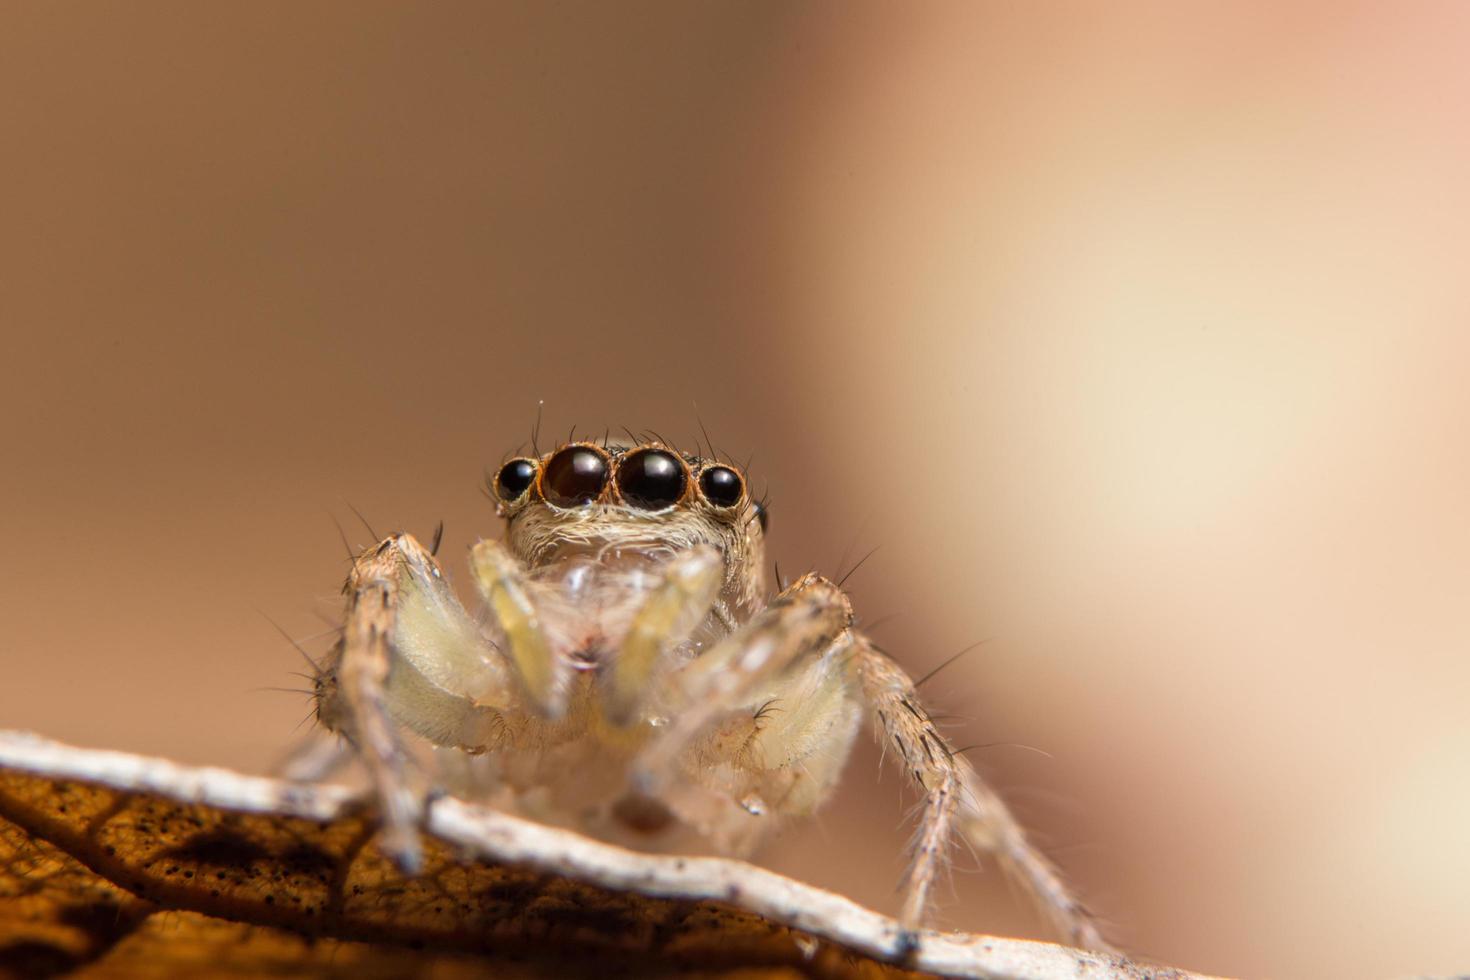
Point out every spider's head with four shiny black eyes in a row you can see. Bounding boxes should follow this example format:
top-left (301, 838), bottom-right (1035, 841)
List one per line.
top-left (488, 442), bottom-right (766, 601)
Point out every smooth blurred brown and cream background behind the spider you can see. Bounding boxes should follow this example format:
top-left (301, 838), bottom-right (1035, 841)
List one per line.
top-left (0, 3), bottom-right (1470, 977)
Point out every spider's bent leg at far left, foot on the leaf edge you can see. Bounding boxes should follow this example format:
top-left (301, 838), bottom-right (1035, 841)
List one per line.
top-left (316, 533), bottom-right (512, 871)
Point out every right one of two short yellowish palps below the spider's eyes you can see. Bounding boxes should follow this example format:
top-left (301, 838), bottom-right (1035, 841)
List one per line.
top-left (601, 547), bottom-right (725, 727)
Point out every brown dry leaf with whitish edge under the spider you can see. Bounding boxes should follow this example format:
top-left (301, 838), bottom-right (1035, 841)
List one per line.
top-left (0, 732), bottom-right (1217, 980)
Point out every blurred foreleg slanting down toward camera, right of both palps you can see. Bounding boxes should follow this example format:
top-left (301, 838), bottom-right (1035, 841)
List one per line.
top-left (632, 574), bottom-right (853, 795)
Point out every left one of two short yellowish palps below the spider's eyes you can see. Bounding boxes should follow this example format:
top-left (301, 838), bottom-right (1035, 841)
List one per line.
top-left (469, 541), bottom-right (567, 718)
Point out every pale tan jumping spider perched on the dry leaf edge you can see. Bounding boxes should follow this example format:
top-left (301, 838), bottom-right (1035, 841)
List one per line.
top-left (315, 436), bottom-right (1107, 949)
